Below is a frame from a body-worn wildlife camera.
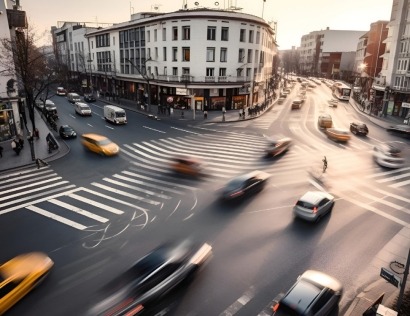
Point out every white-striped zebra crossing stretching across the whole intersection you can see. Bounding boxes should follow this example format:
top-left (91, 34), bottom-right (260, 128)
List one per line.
top-left (0, 132), bottom-right (410, 231)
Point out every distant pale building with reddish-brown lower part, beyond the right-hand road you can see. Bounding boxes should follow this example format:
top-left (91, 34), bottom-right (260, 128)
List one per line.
top-left (299, 28), bottom-right (366, 80)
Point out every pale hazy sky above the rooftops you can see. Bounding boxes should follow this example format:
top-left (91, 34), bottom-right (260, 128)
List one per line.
top-left (20, 0), bottom-right (393, 50)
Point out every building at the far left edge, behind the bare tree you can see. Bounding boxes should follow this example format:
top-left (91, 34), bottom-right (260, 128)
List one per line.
top-left (0, 0), bottom-right (27, 142)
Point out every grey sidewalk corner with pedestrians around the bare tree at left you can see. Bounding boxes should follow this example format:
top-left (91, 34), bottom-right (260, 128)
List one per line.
top-left (0, 109), bottom-right (70, 173)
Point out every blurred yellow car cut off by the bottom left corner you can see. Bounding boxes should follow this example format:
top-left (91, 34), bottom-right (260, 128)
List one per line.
top-left (0, 252), bottom-right (54, 315)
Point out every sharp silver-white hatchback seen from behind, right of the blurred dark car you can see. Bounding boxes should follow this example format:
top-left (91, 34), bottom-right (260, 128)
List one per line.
top-left (293, 191), bottom-right (335, 222)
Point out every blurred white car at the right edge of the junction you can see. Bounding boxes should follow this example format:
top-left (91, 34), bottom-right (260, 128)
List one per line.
top-left (373, 142), bottom-right (405, 168)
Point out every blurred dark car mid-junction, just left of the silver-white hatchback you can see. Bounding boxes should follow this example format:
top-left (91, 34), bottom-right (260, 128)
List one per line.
top-left (221, 170), bottom-right (270, 201)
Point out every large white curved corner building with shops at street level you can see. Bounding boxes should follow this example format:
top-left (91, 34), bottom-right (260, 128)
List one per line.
top-left (55, 8), bottom-right (277, 110)
